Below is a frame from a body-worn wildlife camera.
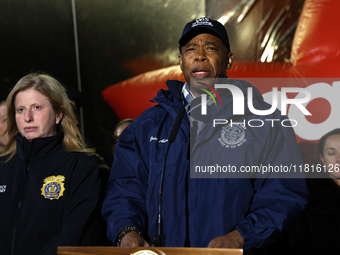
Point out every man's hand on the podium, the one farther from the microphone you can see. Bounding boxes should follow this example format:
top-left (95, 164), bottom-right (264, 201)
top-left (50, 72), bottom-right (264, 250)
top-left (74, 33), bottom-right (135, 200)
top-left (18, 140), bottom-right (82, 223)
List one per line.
top-left (208, 230), bottom-right (244, 248)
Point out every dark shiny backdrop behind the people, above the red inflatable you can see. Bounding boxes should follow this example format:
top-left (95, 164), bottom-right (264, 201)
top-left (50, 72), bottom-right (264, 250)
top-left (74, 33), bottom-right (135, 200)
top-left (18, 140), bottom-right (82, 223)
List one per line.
top-left (0, 0), bottom-right (304, 164)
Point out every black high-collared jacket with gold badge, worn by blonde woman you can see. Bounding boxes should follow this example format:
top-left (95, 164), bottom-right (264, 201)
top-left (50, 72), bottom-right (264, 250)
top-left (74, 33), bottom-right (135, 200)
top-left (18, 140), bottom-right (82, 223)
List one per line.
top-left (0, 133), bottom-right (100, 255)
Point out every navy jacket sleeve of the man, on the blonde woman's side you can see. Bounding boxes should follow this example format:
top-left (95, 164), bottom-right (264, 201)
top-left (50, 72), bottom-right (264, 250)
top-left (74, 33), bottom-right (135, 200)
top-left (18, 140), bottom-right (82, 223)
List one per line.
top-left (102, 126), bottom-right (149, 244)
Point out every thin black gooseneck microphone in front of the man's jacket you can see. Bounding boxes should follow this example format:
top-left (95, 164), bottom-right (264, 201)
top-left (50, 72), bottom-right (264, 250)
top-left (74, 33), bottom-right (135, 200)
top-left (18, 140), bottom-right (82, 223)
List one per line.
top-left (150, 107), bottom-right (185, 247)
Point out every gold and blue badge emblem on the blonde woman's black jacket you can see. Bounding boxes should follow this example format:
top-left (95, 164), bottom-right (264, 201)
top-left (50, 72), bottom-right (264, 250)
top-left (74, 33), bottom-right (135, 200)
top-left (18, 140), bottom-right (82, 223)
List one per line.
top-left (41, 175), bottom-right (65, 200)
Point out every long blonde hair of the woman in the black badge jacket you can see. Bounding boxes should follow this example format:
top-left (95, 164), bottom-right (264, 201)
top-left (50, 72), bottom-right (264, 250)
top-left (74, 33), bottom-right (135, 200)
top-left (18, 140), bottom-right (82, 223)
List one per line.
top-left (2, 73), bottom-right (94, 160)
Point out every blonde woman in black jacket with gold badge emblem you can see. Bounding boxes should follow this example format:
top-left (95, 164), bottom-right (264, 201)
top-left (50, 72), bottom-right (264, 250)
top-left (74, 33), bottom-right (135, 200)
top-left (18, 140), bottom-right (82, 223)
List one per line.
top-left (0, 74), bottom-right (104, 254)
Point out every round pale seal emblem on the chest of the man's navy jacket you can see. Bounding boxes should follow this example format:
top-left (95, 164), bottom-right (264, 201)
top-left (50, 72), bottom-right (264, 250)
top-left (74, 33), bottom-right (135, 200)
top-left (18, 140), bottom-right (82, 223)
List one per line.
top-left (218, 125), bottom-right (247, 148)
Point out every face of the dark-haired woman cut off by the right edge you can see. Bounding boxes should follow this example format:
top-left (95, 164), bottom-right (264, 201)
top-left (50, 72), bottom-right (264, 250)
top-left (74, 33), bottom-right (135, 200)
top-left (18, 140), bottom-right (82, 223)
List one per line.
top-left (320, 134), bottom-right (340, 179)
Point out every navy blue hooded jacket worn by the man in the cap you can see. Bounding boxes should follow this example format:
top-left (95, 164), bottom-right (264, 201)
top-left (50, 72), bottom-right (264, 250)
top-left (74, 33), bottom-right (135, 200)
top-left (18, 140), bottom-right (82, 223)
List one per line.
top-left (102, 78), bottom-right (307, 248)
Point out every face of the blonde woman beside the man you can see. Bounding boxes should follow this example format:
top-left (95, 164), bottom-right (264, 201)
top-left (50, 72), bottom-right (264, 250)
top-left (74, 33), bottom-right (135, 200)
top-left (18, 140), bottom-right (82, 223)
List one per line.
top-left (14, 88), bottom-right (62, 140)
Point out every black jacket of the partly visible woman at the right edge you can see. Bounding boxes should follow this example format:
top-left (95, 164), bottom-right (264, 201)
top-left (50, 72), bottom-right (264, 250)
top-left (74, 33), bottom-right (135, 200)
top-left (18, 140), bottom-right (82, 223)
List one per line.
top-left (289, 179), bottom-right (340, 255)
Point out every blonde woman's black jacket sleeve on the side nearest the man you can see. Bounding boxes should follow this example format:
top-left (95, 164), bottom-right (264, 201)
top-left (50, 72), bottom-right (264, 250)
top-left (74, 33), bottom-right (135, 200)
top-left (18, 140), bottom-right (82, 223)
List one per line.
top-left (41, 156), bottom-right (101, 255)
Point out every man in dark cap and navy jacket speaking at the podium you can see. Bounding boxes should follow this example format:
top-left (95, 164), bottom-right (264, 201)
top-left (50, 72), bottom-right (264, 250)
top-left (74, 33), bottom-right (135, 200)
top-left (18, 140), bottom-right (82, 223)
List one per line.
top-left (102, 18), bottom-right (307, 248)
